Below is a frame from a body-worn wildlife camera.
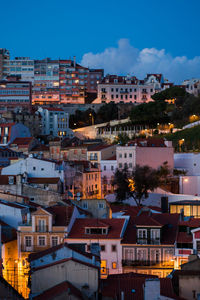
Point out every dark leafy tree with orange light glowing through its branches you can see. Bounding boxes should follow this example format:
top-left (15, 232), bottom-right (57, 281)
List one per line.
top-left (113, 165), bottom-right (160, 206)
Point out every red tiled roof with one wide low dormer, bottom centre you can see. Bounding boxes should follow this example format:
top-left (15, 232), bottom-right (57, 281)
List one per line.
top-left (67, 219), bottom-right (125, 239)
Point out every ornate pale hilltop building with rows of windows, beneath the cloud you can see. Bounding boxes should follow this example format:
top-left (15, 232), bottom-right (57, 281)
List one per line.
top-left (95, 74), bottom-right (164, 104)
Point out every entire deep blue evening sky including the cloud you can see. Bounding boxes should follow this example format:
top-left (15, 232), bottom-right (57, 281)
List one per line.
top-left (0, 0), bottom-right (200, 83)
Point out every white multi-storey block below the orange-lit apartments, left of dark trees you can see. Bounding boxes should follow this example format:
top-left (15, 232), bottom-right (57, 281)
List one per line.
top-left (38, 107), bottom-right (73, 137)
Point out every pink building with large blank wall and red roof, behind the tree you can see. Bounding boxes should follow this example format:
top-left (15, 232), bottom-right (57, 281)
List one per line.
top-left (116, 138), bottom-right (174, 171)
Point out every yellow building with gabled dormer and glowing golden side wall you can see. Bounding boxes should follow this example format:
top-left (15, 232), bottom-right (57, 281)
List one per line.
top-left (17, 205), bottom-right (73, 298)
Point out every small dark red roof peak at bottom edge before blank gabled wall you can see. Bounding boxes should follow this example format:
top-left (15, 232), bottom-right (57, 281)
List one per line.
top-left (33, 281), bottom-right (84, 300)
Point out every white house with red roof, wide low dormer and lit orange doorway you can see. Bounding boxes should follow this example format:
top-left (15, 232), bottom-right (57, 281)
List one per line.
top-left (65, 218), bottom-right (128, 278)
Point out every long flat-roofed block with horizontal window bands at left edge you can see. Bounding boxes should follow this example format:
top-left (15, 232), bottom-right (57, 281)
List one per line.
top-left (0, 78), bottom-right (32, 112)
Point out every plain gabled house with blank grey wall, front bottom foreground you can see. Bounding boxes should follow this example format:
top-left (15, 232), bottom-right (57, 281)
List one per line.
top-left (29, 243), bottom-right (100, 300)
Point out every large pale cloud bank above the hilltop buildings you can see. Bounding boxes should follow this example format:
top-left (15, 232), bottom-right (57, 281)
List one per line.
top-left (81, 39), bottom-right (200, 83)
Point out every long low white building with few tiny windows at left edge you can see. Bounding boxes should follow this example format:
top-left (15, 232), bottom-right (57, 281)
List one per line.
top-left (1, 157), bottom-right (64, 182)
